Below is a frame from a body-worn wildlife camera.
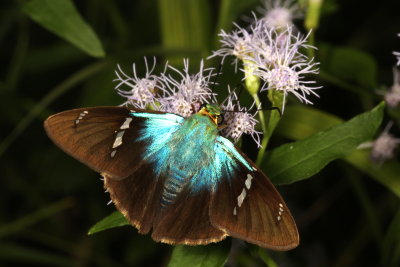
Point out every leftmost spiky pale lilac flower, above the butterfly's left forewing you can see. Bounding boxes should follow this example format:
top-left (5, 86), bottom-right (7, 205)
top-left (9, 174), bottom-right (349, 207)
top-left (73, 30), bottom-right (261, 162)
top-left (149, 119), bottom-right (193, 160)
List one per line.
top-left (114, 58), bottom-right (158, 109)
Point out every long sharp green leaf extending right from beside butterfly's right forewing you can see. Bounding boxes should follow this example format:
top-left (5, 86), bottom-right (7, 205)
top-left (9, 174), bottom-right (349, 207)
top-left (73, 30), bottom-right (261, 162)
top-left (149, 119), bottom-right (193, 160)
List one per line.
top-left (262, 103), bottom-right (384, 184)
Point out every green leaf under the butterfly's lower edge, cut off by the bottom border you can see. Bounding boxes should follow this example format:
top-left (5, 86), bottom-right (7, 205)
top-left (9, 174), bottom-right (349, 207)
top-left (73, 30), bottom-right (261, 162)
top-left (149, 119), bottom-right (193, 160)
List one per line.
top-left (168, 241), bottom-right (230, 267)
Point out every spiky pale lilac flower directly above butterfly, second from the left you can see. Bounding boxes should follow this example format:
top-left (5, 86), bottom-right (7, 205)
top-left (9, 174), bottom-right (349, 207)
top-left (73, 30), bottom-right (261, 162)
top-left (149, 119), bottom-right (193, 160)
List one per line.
top-left (157, 60), bottom-right (214, 117)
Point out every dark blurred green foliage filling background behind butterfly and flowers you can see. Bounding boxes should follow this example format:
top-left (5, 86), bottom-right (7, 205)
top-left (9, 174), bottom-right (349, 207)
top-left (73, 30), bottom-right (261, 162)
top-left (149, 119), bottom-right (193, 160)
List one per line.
top-left (0, 0), bottom-right (400, 266)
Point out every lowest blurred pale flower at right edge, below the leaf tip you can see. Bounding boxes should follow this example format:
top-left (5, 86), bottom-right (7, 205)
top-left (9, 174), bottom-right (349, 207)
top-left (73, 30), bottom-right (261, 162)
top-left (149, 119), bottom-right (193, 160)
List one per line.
top-left (371, 122), bottom-right (400, 163)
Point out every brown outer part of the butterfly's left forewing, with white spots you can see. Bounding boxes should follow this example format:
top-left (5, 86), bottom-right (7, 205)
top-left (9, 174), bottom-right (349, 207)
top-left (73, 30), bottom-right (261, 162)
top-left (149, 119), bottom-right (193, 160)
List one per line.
top-left (44, 107), bottom-right (155, 179)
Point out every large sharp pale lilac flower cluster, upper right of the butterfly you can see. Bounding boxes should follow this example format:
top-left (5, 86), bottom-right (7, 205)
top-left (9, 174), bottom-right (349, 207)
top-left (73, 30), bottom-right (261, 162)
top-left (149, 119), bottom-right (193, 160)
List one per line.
top-left (211, 15), bottom-right (321, 109)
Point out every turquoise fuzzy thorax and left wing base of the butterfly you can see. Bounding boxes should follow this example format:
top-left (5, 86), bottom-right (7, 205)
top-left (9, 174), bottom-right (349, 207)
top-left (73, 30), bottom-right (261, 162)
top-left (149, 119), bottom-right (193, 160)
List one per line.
top-left (137, 113), bottom-right (218, 197)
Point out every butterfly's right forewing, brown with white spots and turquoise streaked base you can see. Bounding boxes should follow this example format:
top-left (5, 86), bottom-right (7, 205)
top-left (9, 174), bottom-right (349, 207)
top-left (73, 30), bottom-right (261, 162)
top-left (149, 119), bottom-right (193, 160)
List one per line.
top-left (210, 137), bottom-right (299, 250)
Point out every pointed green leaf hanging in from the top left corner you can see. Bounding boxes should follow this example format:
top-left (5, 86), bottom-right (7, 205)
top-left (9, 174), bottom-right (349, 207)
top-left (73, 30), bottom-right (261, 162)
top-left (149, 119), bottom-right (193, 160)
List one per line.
top-left (23, 0), bottom-right (105, 57)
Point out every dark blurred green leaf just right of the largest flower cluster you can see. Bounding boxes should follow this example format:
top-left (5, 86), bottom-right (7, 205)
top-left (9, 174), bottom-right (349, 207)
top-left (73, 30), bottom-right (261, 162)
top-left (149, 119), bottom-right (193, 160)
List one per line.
top-left (320, 45), bottom-right (377, 89)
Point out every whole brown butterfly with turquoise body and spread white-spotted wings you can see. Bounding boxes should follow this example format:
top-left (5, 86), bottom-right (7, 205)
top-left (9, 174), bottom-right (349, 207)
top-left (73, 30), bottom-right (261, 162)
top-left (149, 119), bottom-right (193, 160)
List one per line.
top-left (44, 104), bottom-right (299, 250)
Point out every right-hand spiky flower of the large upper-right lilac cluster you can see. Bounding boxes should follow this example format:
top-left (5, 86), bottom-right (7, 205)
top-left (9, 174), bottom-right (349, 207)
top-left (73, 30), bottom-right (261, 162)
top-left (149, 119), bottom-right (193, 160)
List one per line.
top-left (246, 21), bottom-right (321, 109)
